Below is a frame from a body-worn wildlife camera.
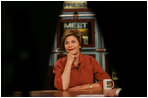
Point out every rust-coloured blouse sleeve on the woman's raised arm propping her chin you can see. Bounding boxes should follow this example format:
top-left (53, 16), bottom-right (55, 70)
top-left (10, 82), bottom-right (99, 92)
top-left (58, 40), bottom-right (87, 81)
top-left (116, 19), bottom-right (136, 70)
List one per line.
top-left (54, 59), bottom-right (64, 90)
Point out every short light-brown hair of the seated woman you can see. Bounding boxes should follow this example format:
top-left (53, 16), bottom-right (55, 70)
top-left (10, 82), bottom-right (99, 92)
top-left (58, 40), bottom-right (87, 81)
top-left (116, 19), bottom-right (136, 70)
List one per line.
top-left (61, 29), bottom-right (83, 50)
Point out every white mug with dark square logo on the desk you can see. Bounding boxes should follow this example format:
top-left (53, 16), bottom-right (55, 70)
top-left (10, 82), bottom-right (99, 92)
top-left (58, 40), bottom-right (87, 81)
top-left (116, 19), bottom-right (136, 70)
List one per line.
top-left (103, 79), bottom-right (114, 92)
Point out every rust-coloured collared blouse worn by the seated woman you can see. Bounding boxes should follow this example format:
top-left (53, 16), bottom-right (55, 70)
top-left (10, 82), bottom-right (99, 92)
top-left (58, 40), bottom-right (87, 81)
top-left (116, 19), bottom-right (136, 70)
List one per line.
top-left (54, 53), bottom-right (111, 90)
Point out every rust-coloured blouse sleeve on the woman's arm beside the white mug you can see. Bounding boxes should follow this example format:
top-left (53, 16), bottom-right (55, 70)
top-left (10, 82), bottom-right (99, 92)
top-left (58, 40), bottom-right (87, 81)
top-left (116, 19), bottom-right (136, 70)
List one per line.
top-left (92, 58), bottom-right (111, 87)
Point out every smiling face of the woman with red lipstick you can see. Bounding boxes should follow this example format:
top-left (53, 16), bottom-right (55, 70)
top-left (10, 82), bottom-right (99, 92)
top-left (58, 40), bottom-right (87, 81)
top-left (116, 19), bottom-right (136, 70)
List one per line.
top-left (64, 35), bottom-right (81, 55)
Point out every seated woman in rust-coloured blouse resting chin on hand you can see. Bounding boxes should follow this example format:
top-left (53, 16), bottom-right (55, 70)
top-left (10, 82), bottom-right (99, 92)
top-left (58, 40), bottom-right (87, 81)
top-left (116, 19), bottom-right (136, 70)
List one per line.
top-left (54, 30), bottom-right (111, 91)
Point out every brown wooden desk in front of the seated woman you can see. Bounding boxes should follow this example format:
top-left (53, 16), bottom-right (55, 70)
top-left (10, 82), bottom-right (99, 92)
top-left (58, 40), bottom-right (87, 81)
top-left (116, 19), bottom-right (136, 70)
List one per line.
top-left (15, 90), bottom-right (103, 97)
